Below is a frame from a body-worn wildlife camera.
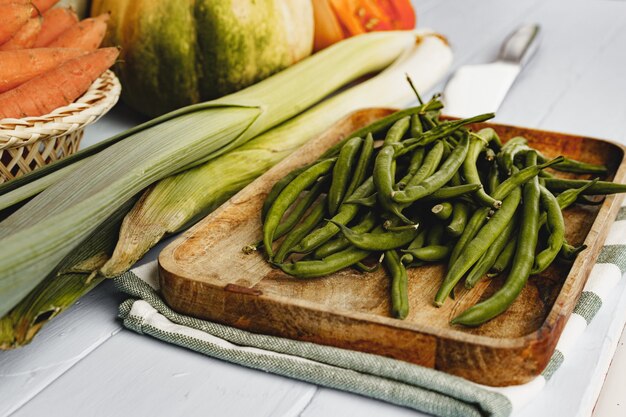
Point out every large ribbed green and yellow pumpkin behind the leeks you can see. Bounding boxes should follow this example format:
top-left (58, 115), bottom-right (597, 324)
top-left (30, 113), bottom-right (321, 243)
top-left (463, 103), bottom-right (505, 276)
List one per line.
top-left (91, 0), bottom-right (313, 116)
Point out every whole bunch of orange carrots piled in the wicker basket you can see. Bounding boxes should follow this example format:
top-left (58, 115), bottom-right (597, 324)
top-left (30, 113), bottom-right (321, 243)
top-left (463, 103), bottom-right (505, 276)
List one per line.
top-left (0, 0), bottom-right (119, 119)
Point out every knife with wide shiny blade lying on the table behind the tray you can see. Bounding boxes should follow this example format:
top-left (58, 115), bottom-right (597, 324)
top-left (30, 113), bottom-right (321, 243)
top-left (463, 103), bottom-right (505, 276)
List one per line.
top-left (443, 24), bottom-right (539, 117)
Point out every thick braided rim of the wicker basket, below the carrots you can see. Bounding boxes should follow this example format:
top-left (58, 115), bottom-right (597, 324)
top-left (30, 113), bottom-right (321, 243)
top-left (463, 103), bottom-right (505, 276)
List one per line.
top-left (0, 70), bottom-right (121, 150)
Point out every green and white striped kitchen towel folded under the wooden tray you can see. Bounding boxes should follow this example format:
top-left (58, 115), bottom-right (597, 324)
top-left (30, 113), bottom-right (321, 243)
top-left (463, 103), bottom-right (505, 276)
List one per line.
top-left (116, 196), bottom-right (626, 417)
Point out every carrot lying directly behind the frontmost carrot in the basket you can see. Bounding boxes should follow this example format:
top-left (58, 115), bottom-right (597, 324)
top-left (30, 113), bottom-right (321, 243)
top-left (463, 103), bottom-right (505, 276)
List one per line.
top-left (0, 48), bottom-right (88, 93)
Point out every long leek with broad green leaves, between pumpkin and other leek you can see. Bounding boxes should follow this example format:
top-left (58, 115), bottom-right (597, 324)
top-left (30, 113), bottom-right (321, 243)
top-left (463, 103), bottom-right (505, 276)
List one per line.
top-left (0, 32), bottom-right (415, 316)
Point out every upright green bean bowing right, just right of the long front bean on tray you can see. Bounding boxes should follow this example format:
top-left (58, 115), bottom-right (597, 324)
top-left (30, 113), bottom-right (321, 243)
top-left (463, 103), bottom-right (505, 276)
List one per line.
top-left (531, 186), bottom-right (565, 275)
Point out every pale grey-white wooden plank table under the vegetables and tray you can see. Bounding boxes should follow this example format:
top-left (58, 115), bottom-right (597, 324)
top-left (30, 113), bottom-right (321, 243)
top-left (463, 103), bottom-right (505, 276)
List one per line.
top-left (0, 0), bottom-right (626, 417)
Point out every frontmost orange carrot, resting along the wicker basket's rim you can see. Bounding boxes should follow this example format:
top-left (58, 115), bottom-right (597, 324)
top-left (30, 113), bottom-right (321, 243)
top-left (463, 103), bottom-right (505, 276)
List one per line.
top-left (0, 48), bottom-right (119, 119)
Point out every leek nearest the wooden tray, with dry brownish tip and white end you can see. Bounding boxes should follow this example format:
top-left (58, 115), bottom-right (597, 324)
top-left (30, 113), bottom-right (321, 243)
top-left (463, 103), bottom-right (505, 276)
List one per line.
top-left (101, 31), bottom-right (452, 277)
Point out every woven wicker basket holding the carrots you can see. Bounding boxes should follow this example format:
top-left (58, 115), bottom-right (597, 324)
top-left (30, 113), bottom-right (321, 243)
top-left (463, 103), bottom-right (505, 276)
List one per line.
top-left (0, 70), bottom-right (121, 184)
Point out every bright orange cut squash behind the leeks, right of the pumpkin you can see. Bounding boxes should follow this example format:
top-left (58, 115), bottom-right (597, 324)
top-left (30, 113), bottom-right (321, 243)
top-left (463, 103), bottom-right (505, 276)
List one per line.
top-left (313, 0), bottom-right (415, 50)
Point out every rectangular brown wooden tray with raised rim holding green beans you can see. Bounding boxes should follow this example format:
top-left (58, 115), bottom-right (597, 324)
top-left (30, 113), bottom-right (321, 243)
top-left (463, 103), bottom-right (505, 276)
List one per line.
top-left (159, 109), bottom-right (626, 386)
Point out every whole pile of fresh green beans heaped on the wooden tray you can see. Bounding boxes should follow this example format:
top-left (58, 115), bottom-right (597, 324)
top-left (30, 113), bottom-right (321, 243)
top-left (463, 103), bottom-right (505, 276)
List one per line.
top-left (262, 96), bottom-right (626, 326)
